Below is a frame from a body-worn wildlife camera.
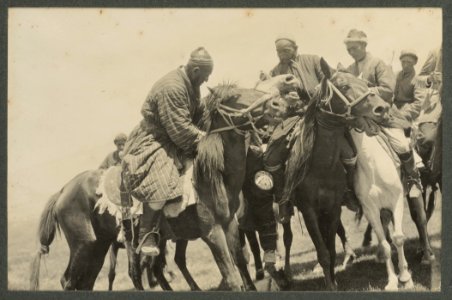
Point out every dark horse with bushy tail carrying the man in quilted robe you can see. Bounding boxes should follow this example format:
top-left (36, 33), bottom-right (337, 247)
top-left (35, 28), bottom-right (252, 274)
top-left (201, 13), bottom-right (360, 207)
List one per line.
top-left (30, 76), bottom-right (297, 290)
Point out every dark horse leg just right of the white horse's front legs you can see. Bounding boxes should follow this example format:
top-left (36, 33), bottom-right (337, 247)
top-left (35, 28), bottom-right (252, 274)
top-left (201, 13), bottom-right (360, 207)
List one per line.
top-left (407, 196), bottom-right (435, 263)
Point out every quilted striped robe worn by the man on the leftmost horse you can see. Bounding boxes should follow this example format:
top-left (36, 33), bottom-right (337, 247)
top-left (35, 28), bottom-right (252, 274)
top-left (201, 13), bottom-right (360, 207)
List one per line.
top-left (123, 67), bottom-right (202, 202)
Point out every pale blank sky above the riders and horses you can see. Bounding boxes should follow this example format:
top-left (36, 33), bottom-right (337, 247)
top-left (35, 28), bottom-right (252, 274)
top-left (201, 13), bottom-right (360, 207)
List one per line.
top-left (8, 8), bottom-right (442, 207)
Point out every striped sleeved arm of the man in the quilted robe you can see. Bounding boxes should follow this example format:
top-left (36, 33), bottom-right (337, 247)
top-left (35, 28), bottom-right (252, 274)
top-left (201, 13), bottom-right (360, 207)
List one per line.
top-left (158, 88), bottom-right (204, 154)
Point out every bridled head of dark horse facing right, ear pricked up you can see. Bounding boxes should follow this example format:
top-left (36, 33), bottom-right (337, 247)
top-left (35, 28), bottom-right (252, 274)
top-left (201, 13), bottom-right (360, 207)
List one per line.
top-left (319, 58), bottom-right (390, 123)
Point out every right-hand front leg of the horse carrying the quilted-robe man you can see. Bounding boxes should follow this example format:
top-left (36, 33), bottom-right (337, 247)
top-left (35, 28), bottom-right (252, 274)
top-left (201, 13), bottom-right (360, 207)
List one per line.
top-left (225, 218), bottom-right (256, 291)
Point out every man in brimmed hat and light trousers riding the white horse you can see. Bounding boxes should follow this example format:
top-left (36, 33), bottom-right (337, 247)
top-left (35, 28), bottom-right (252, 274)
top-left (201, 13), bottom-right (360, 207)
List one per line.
top-left (344, 29), bottom-right (422, 197)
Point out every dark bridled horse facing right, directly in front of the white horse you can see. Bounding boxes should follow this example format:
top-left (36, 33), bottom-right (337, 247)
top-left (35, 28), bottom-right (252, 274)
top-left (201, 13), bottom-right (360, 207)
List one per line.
top-left (283, 58), bottom-right (389, 290)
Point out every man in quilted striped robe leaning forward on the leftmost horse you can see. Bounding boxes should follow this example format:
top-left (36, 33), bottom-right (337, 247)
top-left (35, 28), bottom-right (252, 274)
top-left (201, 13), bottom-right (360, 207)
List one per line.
top-left (121, 47), bottom-right (213, 256)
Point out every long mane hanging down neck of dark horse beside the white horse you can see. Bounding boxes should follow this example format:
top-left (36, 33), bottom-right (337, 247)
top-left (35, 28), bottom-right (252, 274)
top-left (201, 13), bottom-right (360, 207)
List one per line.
top-left (282, 85), bottom-right (321, 201)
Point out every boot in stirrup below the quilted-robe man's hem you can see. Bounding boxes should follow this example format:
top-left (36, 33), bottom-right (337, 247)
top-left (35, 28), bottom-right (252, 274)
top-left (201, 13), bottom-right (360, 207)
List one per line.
top-left (136, 202), bottom-right (163, 256)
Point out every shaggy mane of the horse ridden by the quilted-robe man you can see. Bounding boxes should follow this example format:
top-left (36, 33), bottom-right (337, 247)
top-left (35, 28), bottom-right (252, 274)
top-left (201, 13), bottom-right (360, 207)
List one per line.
top-left (193, 82), bottom-right (236, 220)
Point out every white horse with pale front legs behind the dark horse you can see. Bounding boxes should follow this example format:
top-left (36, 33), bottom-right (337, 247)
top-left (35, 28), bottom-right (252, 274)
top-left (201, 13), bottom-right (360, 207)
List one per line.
top-left (351, 130), bottom-right (413, 290)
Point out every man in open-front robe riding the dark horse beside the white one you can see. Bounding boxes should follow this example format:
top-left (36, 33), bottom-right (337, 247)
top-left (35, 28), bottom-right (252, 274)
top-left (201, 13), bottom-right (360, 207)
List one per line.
top-left (261, 37), bottom-right (358, 222)
